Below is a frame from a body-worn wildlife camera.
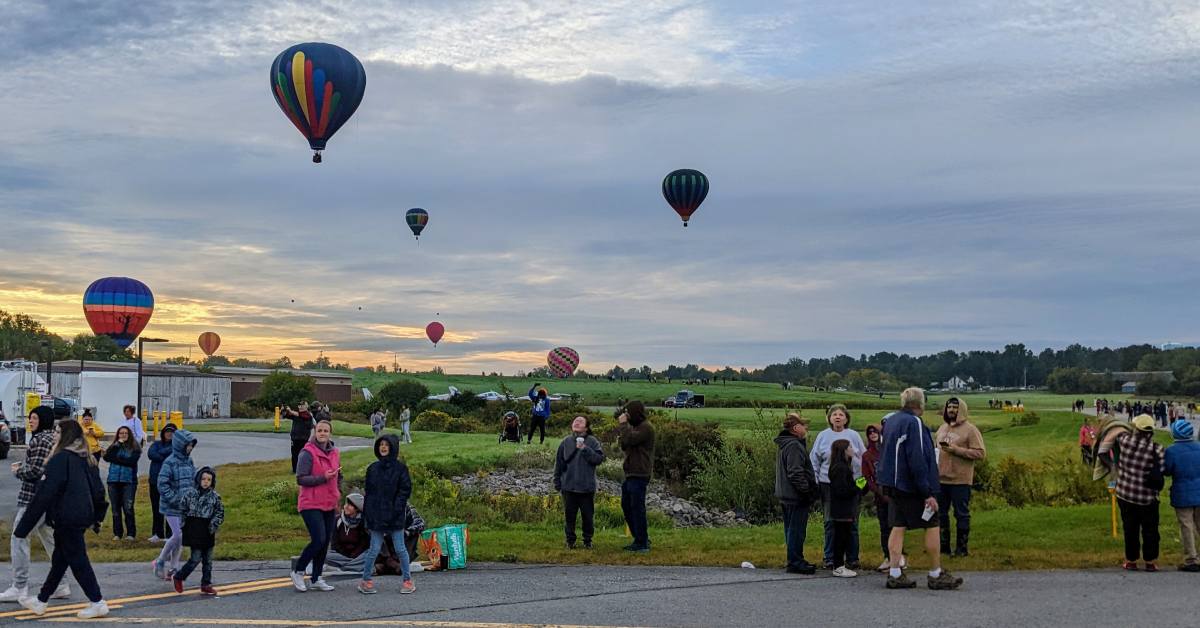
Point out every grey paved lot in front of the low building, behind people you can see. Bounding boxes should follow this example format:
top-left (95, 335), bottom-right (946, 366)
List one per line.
top-left (0, 432), bottom-right (371, 521)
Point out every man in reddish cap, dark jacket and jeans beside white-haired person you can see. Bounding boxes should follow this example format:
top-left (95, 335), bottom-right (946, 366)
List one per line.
top-left (775, 412), bottom-right (820, 575)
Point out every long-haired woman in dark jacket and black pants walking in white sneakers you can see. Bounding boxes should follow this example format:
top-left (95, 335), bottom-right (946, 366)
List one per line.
top-left (13, 420), bottom-right (108, 620)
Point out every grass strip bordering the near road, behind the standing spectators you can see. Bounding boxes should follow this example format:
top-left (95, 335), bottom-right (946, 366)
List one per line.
top-left (0, 425), bottom-right (1180, 570)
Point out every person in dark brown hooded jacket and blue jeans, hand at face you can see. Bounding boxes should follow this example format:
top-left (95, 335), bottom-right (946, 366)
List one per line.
top-left (617, 401), bottom-right (654, 552)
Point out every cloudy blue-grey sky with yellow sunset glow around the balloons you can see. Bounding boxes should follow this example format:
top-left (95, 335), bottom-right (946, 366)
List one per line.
top-left (0, 0), bottom-right (1200, 373)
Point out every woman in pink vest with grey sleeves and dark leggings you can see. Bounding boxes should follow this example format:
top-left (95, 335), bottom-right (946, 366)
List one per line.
top-left (292, 420), bottom-right (342, 591)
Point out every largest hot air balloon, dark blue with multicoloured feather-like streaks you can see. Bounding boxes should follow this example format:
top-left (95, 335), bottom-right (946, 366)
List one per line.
top-left (271, 42), bottom-right (367, 163)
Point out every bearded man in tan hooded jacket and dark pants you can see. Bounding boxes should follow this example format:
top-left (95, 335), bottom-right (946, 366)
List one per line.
top-left (934, 397), bottom-right (986, 556)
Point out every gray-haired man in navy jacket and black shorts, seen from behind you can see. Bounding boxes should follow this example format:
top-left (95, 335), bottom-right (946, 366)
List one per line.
top-left (876, 388), bottom-right (962, 590)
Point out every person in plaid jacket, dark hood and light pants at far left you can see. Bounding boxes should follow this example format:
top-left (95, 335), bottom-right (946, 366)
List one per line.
top-left (0, 406), bottom-right (71, 602)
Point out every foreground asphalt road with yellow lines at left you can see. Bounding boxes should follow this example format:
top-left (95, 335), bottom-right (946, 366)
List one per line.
top-left (0, 563), bottom-right (1200, 628)
